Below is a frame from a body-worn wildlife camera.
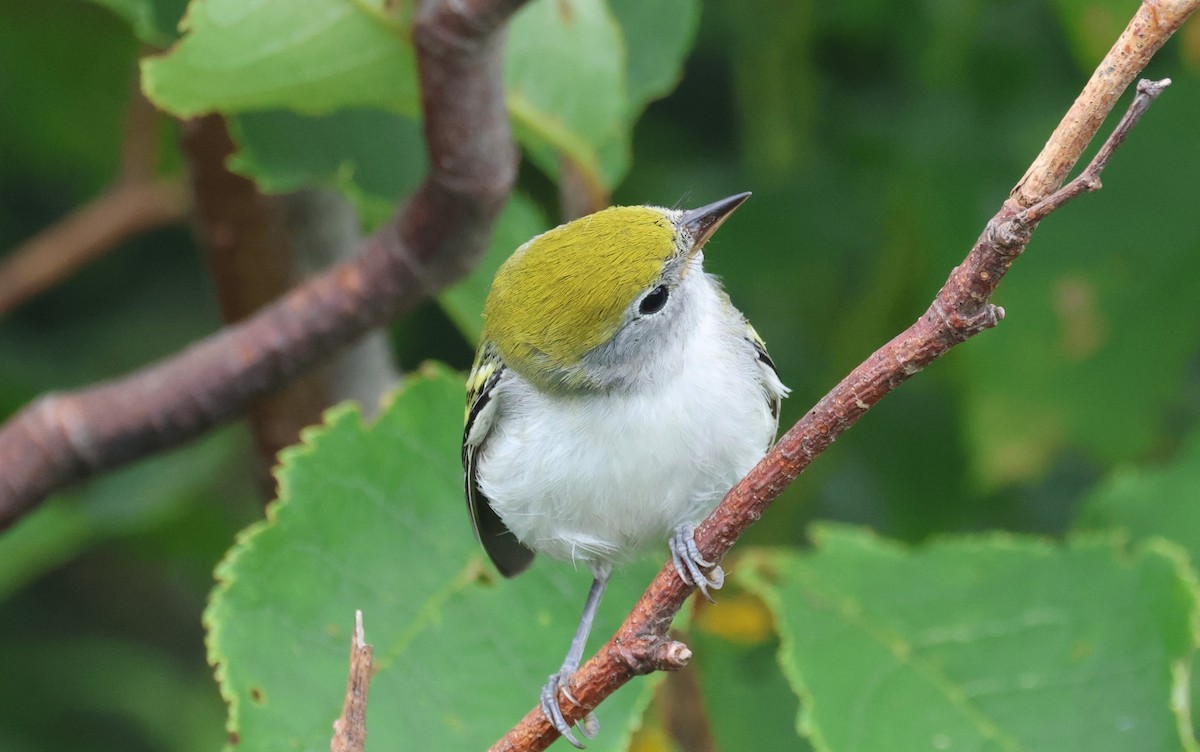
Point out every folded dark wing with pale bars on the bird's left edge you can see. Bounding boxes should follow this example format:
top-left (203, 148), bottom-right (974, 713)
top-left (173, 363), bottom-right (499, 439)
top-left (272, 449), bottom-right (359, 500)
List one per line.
top-left (462, 343), bottom-right (533, 577)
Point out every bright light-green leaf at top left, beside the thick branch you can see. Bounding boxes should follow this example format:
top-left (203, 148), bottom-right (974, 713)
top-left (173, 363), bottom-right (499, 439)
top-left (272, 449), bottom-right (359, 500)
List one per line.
top-left (142, 0), bottom-right (419, 118)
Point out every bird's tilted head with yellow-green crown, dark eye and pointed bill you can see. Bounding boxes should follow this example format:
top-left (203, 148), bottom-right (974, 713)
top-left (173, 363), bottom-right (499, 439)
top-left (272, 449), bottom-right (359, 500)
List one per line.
top-left (484, 193), bottom-right (750, 391)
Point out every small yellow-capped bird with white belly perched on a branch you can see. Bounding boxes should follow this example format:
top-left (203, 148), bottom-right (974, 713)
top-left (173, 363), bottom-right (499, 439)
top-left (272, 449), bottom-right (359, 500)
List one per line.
top-left (462, 193), bottom-right (787, 748)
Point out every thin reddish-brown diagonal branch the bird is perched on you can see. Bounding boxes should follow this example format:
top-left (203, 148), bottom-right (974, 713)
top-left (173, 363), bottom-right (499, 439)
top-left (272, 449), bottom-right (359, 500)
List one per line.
top-left (492, 0), bottom-right (1200, 752)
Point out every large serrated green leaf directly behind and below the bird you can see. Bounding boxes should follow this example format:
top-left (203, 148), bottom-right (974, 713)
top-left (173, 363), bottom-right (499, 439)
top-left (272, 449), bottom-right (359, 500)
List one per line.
top-left (205, 368), bottom-right (655, 751)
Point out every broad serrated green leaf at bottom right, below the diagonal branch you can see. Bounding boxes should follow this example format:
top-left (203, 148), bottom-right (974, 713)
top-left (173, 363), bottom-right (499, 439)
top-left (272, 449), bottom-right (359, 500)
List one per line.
top-left (740, 527), bottom-right (1198, 752)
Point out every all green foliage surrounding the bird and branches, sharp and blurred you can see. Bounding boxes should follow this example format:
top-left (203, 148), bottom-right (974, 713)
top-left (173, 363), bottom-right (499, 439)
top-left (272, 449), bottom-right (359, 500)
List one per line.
top-left (0, 0), bottom-right (1200, 751)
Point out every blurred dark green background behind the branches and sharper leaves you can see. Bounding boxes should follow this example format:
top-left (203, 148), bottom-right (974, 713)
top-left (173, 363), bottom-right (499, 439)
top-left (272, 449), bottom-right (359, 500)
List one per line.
top-left (0, 0), bottom-right (1200, 751)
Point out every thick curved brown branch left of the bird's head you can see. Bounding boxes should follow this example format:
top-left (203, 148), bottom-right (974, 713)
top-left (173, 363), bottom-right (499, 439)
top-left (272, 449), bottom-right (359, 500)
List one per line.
top-left (0, 0), bottom-right (522, 528)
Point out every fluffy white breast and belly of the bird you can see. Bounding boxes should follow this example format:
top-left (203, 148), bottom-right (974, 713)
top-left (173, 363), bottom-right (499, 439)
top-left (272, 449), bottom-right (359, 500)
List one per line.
top-left (478, 273), bottom-right (784, 568)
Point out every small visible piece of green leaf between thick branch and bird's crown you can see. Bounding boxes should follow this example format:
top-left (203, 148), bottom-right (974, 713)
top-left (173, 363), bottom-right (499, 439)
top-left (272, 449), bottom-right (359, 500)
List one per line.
top-left (438, 192), bottom-right (546, 343)
